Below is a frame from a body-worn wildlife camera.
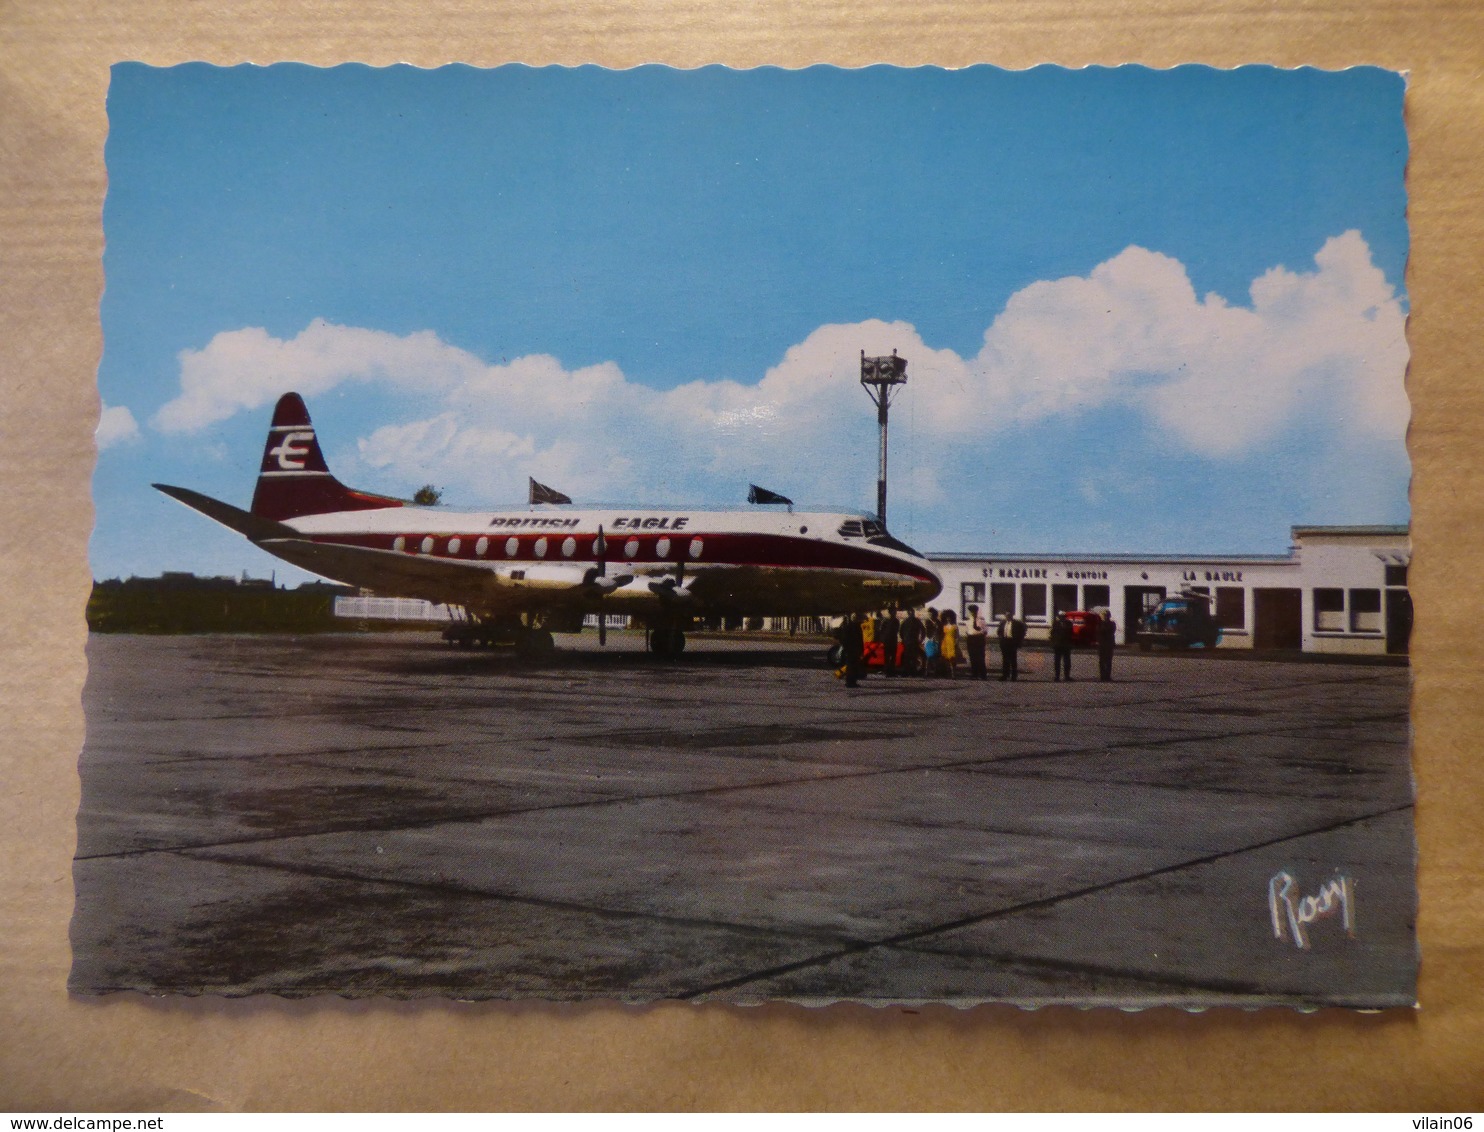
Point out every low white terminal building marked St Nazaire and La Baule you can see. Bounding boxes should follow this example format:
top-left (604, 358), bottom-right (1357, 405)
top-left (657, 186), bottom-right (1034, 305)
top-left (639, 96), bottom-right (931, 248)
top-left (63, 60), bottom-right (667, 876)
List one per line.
top-left (929, 527), bottom-right (1411, 654)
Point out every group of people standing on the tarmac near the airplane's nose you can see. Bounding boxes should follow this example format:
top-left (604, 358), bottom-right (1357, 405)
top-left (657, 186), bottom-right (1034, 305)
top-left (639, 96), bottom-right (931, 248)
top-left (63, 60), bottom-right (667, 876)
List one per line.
top-left (835, 605), bottom-right (1117, 688)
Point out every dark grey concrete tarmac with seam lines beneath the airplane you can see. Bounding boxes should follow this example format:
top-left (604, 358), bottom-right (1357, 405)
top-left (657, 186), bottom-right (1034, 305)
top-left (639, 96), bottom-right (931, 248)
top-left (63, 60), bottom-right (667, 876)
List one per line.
top-left (71, 634), bottom-right (1416, 1007)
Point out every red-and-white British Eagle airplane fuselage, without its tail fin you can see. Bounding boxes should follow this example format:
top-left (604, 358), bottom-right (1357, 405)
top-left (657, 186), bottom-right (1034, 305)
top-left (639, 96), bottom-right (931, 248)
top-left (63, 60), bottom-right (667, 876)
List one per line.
top-left (280, 507), bottom-right (941, 616)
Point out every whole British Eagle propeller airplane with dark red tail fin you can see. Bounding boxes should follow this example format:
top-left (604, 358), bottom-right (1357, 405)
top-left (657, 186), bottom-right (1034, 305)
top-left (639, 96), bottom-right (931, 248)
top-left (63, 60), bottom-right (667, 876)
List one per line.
top-left (154, 393), bottom-right (942, 654)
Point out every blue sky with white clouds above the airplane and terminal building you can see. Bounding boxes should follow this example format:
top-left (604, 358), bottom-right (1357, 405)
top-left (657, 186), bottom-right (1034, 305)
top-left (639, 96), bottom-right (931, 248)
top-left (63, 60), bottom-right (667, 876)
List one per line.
top-left (92, 64), bottom-right (1408, 577)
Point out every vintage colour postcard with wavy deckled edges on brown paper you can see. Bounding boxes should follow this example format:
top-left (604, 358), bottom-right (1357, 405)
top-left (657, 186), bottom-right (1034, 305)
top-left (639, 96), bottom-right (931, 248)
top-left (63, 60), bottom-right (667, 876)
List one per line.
top-left (78, 64), bottom-right (1417, 1007)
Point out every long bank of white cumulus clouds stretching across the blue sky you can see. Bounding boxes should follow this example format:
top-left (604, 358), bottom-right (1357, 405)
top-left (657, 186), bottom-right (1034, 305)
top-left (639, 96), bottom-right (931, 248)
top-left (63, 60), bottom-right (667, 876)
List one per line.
top-left (153, 231), bottom-right (1407, 522)
